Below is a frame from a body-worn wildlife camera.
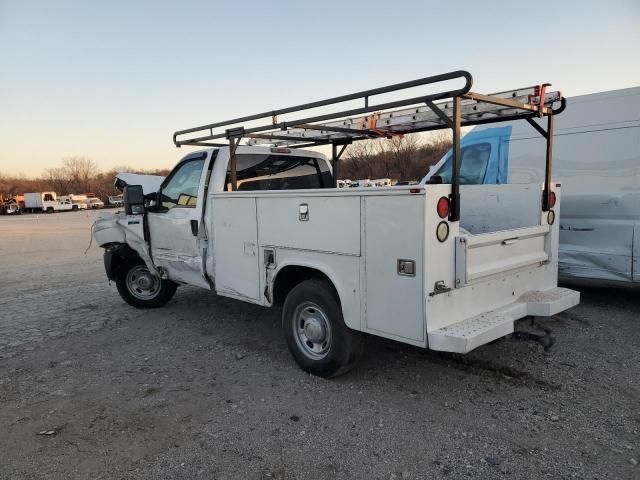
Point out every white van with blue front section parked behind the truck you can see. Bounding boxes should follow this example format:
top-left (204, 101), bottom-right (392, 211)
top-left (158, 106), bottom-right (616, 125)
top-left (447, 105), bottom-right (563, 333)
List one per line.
top-left (425, 87), bottom-right (640, 285)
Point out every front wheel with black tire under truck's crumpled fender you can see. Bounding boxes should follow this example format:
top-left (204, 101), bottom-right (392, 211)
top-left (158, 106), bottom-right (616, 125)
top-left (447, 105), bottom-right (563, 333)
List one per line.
top-left (116, 262), bottom-right (178, 308)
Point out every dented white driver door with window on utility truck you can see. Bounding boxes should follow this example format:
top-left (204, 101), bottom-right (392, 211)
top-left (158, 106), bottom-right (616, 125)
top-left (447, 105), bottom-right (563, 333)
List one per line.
top-left (148, 153), bottom-right (211, 289)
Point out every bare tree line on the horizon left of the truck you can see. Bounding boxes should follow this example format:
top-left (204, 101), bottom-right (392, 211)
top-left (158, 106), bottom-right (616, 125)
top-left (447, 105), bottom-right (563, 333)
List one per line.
top-left (0, 157), bottom-right (169, 199)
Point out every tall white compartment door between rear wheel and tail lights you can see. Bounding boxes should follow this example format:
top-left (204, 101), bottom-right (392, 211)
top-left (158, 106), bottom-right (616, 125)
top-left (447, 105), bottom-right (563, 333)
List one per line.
top-left (363, 195), bottom-right (425, 341)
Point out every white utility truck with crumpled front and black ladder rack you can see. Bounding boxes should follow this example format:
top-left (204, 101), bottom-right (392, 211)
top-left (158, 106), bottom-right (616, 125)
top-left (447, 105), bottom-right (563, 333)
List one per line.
top-left (94, 71), bottom-right (579, 376)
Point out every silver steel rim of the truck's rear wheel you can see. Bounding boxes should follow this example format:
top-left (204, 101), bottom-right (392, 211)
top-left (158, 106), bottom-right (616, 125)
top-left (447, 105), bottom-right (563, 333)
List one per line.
top-left (292, 302), bottom-right (331, 360)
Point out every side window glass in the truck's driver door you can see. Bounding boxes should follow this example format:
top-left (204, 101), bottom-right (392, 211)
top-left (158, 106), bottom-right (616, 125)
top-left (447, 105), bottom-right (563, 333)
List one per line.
top-left (160, 156), bottom-right (205, 210)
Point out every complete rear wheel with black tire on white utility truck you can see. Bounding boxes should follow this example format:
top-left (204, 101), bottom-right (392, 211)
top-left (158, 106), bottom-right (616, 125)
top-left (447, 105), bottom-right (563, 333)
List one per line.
top-left (282, 279), bottom-right (363, 377)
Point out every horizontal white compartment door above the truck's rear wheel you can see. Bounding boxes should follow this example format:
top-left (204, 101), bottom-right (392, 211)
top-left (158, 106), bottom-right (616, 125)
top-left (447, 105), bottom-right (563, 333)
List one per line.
top-left (257, 195), bottom-right (360, 255)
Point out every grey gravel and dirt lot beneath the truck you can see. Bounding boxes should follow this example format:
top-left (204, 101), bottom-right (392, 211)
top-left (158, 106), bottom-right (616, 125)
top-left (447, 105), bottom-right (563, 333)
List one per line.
top-left (0, 213), bottom-right (640, 479)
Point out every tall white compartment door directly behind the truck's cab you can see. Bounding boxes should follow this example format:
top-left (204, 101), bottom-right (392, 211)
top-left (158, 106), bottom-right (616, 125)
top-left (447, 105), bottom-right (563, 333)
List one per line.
top-left (209, 197), bottom-right (261, 301)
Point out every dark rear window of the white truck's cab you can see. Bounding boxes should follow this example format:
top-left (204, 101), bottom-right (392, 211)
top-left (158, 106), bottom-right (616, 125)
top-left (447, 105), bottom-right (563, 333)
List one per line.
top-left (226, 154), bottom-right (333, 191)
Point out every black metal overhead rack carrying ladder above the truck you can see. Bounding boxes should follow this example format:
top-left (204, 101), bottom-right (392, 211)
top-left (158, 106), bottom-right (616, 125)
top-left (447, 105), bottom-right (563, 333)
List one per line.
top-left (173, 70), bottom-right (566, 221)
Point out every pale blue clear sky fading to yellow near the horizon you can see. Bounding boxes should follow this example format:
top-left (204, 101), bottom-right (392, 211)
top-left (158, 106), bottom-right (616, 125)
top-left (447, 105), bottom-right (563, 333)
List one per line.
top-left (0, 0), bottom-right (640, 177)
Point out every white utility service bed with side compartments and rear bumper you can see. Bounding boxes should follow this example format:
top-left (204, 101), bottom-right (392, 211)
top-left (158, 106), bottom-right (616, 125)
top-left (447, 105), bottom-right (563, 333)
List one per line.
top-left (207, 185), bottom-right (577, 351)
